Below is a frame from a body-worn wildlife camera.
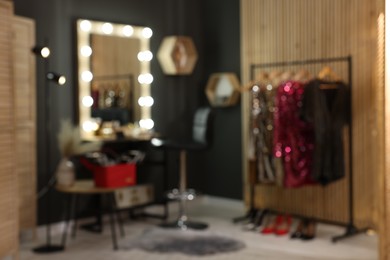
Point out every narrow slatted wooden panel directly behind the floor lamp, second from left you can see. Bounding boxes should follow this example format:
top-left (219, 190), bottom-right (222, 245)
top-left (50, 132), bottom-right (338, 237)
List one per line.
top-left (13, 16), bottom-right (37, 237)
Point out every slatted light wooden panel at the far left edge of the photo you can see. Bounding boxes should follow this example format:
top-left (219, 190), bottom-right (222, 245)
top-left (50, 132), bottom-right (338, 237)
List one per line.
top-left (0, 1), bottom-right (19, 259)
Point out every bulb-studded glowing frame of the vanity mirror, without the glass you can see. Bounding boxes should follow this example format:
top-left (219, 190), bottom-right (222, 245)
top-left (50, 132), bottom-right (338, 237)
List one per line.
top-left (77, 19), bottom-right (154, 139)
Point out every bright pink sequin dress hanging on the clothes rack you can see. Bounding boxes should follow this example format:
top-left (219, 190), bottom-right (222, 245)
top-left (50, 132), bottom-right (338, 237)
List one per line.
top-left (273, 81), bottom-right (316, 188)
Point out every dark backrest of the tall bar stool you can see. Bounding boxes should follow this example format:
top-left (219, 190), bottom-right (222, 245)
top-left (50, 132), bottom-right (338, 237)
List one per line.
top-left (192, 107), bottom-right (213, 145)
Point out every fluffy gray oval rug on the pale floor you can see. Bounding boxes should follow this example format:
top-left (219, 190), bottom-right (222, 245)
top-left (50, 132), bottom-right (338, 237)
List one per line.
top-left (120, 227), bottom-right (245, 256)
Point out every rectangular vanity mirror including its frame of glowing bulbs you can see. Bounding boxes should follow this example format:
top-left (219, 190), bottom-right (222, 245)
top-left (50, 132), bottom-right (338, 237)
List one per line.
top-left (77, 19), bottom-right (154, 139)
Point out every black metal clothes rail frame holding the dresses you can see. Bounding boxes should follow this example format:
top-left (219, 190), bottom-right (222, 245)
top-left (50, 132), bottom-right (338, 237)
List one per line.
top-left (247, 56), bottom-right (368, 242)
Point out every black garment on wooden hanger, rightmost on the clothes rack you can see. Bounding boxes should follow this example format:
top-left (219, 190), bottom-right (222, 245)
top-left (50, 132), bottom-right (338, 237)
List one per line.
top-left (302, 79), bottom-right (351, 185)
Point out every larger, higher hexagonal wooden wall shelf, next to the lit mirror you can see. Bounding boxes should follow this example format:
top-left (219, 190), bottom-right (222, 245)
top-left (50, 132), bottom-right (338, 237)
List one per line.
top-left (157, 36), bottom-right (198, 75)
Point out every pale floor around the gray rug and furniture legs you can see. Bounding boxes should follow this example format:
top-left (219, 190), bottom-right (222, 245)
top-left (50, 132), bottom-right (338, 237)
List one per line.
top-left (20, 197), bottom-right (378, 260)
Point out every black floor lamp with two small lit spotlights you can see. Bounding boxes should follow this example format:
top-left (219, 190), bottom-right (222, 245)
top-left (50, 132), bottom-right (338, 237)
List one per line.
top-left (32, 46), bottom-right (66, 253)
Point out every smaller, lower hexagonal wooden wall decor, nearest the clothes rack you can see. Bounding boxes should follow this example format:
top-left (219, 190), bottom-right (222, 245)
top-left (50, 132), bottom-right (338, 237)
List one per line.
top-left (205, 73), bottom-right (241, 106)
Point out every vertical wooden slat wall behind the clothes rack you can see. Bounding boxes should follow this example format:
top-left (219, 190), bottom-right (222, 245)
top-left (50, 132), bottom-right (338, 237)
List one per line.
top-left (241, 0), bottom-right (382, 230)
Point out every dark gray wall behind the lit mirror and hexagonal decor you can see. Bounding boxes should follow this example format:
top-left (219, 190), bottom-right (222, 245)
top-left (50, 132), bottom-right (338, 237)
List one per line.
top-left (14, 0), bottom-right (242, 223)
